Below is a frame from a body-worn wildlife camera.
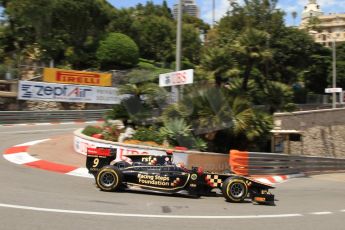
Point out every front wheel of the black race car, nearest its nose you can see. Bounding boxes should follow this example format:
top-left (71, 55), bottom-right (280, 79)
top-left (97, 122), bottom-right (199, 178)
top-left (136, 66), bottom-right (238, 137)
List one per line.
top-left (222, 178), bottom-right (248, 203)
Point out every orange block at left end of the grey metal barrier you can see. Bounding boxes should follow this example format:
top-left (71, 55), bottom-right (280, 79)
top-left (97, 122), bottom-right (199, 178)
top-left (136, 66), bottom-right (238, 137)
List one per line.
top-left (229, 150), bottom-right (249, 176)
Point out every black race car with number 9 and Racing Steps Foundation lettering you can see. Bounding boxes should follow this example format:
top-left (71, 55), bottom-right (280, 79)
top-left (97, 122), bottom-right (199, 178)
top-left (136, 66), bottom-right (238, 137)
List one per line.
top-left (86, 148), bottom-right (274, 205)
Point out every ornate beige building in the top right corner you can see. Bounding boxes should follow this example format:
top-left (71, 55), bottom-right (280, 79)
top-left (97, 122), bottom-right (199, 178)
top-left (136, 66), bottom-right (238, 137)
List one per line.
top-left (300, 0), bottom-right (345, 47)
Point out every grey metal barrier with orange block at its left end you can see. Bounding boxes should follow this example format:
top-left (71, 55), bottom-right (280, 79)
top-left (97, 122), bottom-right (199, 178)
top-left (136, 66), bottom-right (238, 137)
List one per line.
top-left (229, 150), bottom-right (345, 175)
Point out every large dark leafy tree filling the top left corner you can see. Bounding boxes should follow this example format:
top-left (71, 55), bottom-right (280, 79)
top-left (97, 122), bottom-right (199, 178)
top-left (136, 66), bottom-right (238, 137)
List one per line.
top-left (2, 0), bottom-right (113, 68)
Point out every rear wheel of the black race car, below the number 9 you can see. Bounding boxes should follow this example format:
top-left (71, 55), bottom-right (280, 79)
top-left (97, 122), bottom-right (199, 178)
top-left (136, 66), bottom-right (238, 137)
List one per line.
top-left (96, 165), bottom-right (123, 192)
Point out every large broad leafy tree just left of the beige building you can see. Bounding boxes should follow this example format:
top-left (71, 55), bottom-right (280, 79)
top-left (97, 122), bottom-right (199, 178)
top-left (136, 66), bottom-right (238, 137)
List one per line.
top-left (201, 0), bottom-right (329, 107)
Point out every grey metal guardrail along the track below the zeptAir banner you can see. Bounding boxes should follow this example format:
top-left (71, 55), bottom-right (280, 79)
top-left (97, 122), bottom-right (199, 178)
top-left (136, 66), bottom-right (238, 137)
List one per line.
top-left (0, 109), bottom-right (108, 125)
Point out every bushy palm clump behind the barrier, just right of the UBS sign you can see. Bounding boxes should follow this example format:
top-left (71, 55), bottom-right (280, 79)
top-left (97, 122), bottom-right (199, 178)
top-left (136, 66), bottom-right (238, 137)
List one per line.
top-left (161, 84), bottom-right (272, 152)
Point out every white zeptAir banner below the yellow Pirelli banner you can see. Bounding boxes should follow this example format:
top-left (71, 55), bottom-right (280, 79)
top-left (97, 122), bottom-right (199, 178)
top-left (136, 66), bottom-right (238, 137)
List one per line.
top-left (18, 81), bottom-right (122, 104)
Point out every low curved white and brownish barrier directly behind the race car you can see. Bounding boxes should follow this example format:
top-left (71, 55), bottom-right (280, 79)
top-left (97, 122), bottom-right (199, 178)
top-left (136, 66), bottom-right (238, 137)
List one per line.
top-left (74, 129), bottom-right (229, 172)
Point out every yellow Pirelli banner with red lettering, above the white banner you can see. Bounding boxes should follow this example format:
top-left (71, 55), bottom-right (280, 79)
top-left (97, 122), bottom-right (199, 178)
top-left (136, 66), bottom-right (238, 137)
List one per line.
top-left (43, 68), bottom-right (111, 86)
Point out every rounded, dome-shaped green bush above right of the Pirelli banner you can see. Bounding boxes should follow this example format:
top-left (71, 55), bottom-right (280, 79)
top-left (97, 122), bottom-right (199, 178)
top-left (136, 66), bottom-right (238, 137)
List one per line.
top-left (96, 33), bottom-right (139, 69)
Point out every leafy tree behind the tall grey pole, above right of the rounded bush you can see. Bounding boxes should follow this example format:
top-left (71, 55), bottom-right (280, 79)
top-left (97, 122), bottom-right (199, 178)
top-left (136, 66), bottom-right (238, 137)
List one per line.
top-left (108, 1), bottom-right (204, 66)
